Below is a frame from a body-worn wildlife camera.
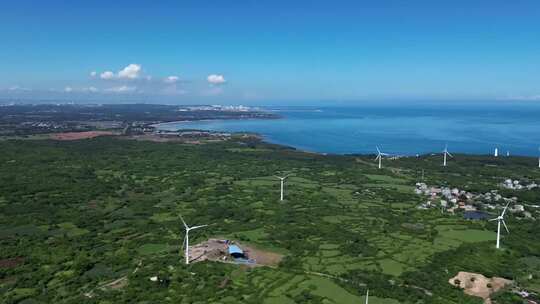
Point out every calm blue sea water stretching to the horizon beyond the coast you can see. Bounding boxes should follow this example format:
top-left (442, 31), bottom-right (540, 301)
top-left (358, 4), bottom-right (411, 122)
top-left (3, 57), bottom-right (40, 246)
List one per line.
top-left (159, 102), bottom-right (540, 156)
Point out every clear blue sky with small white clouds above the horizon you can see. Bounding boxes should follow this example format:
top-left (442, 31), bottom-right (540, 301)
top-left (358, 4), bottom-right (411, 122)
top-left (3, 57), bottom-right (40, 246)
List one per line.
top-left (0, 0), bottom-right (540, 104)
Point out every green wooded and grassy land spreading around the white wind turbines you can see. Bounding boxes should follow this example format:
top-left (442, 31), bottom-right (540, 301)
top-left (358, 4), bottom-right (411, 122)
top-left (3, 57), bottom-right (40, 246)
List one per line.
top-left (0, 136), bottom-right (540, 304)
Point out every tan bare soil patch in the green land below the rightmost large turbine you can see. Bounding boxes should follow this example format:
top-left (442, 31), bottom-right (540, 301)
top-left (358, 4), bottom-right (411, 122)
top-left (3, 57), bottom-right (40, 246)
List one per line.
top-left (448, 271), bottom-right (513, 304)
